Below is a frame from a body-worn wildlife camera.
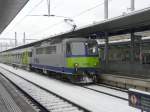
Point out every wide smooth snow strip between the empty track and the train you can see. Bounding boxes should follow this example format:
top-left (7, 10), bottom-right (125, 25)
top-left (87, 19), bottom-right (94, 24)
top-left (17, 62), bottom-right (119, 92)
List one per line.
top-left (0, 64), bottom-right (141, 112)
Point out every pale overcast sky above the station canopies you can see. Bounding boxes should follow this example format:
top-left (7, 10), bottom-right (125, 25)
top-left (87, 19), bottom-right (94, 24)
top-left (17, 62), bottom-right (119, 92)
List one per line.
top-left (0, 0), bottom-right (150, 49)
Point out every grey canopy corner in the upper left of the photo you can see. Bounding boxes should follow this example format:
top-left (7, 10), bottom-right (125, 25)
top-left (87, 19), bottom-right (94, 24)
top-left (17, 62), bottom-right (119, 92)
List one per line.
top-left (0, 0), bottom-right (29, 33)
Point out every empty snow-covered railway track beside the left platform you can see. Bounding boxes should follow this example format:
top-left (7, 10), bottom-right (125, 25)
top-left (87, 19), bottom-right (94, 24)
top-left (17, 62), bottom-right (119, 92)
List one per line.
top-left (0, 67), bottom-right (89, 112)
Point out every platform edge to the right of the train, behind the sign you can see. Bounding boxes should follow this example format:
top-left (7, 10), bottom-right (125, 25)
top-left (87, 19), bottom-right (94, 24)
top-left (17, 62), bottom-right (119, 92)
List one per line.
top-left (99, 73), bottom-right (150, 92)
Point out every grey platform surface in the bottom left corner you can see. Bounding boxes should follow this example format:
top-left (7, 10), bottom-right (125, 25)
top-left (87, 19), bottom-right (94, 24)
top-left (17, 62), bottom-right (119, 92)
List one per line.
top-left (0, 74), bottom-right (37, 112)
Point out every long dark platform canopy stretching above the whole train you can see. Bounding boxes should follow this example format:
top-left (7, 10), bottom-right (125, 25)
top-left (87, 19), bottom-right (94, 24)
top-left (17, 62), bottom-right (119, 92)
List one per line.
top-left (2, 8), bottom-right (150, 50)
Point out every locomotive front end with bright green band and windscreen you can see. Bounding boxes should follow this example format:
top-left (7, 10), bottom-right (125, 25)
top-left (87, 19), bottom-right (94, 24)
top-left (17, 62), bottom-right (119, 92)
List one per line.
top-left (66, 39), bottom-right (100, 83)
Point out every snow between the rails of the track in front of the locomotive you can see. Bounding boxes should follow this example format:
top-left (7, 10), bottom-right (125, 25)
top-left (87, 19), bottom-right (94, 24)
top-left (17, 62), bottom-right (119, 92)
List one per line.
top-left (87, 85), bottom-right (128, 99)
